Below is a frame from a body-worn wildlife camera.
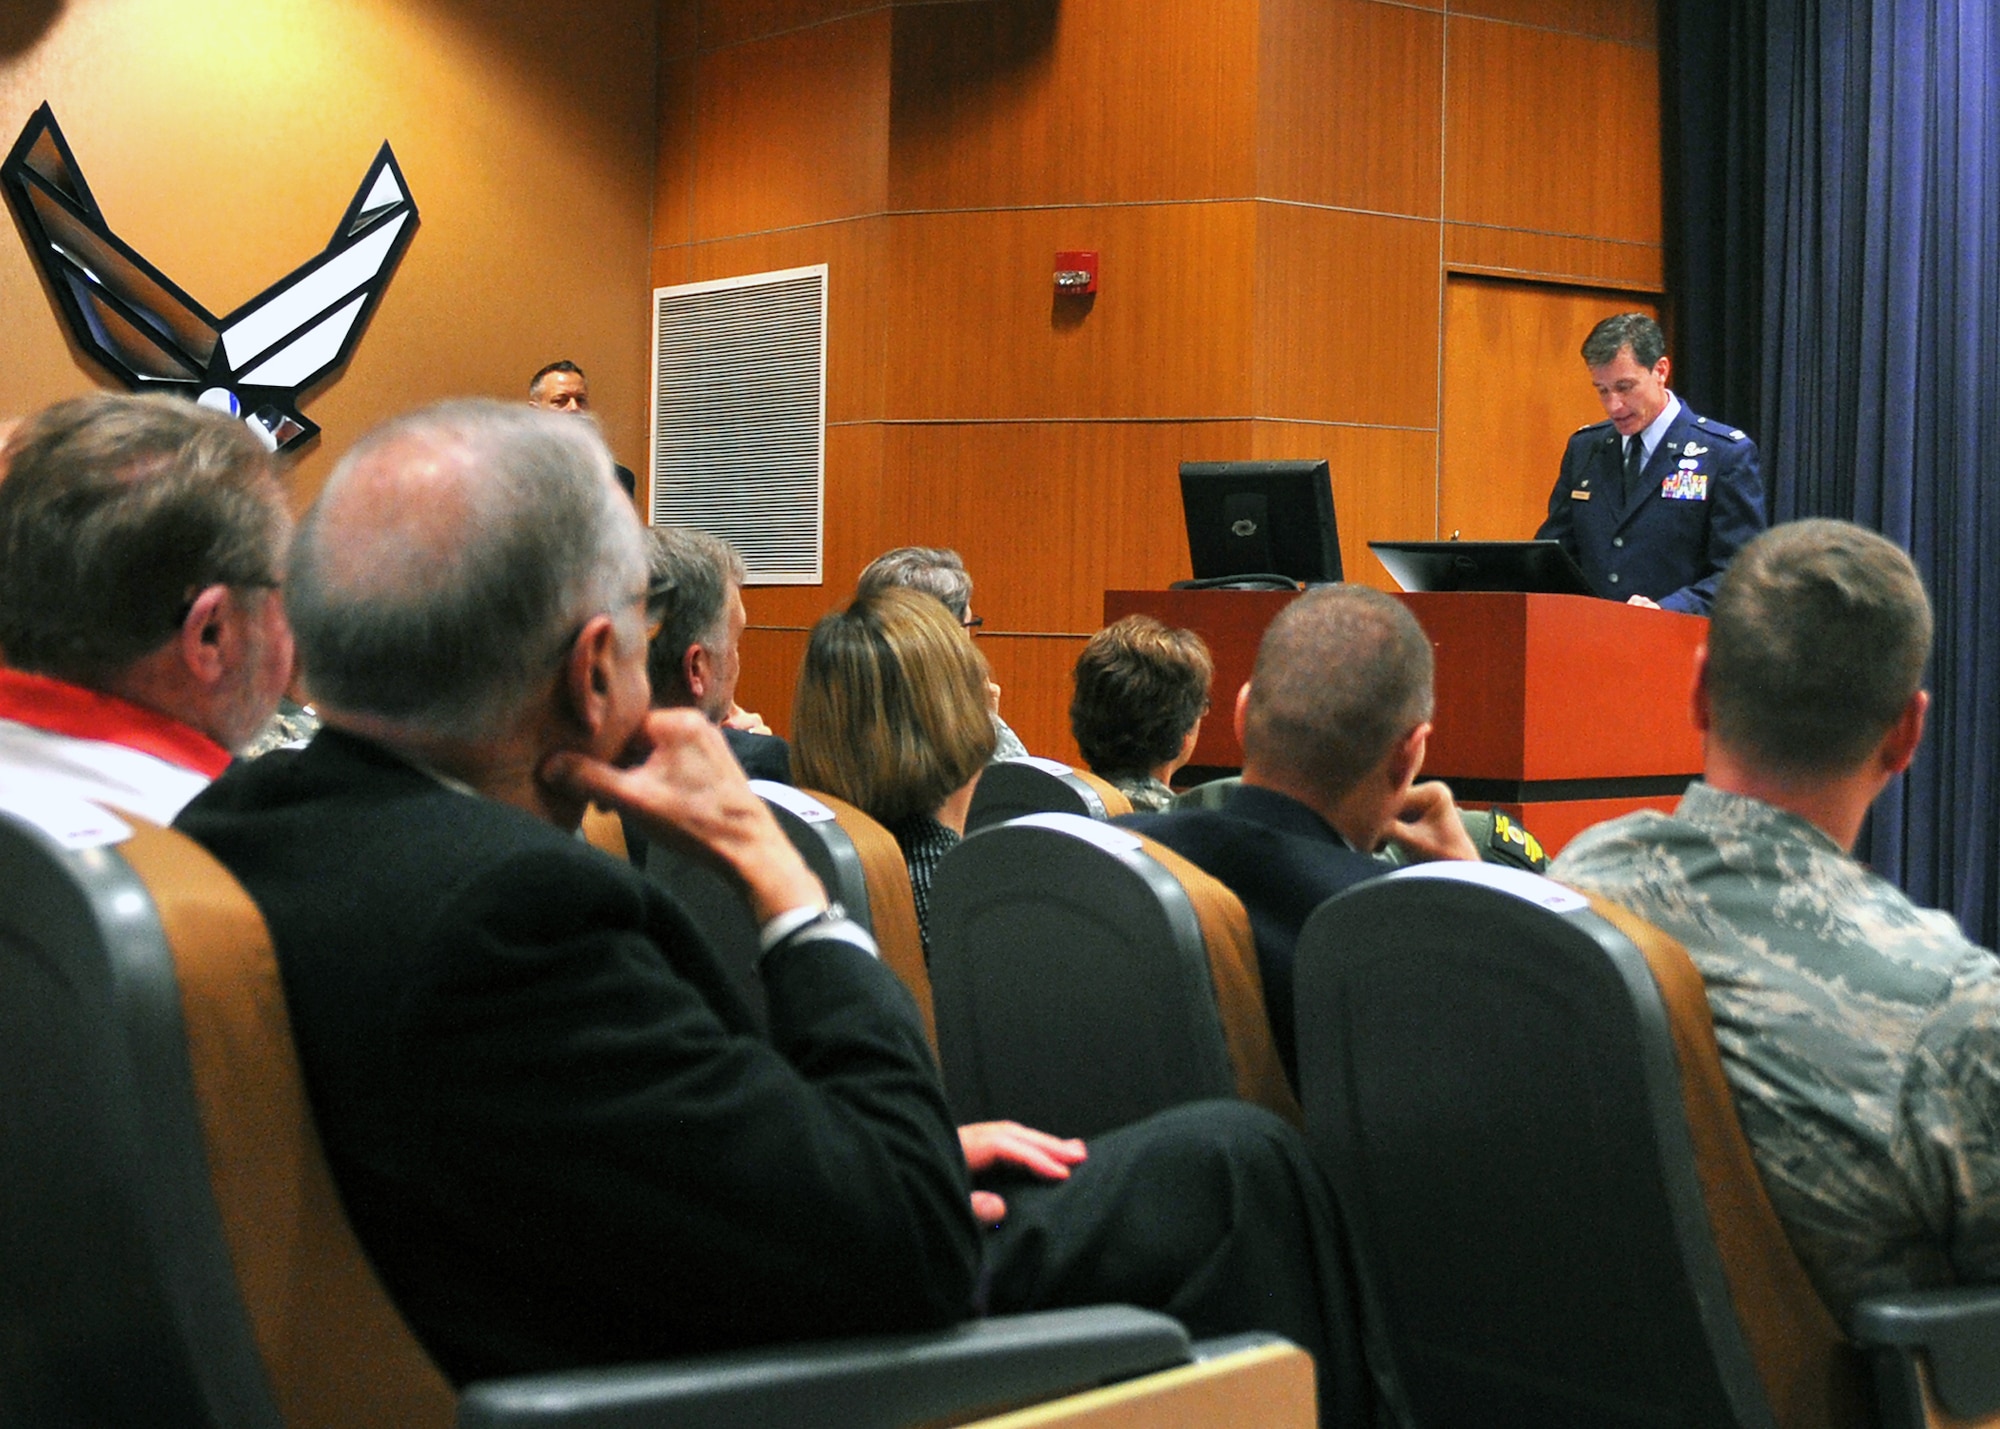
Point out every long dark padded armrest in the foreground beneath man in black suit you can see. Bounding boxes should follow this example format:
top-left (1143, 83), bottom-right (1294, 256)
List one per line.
top-left (458, 1305), bottom-right (1192, 1429)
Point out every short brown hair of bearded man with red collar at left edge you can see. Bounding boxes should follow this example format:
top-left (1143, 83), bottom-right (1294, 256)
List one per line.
top-left (0, 394), bottom-right (292, 686)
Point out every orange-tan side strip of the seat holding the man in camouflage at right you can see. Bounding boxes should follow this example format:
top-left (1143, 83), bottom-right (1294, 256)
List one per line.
top-left (1590, 897), bottom-right (1870, 1429)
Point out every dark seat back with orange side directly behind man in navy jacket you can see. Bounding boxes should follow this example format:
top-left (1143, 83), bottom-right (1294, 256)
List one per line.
top-left (930, 815), bottom-right (1300, 1137)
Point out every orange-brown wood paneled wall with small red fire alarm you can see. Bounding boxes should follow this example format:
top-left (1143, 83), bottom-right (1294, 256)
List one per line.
top-left (652, 0), bottom-right (1662, 757)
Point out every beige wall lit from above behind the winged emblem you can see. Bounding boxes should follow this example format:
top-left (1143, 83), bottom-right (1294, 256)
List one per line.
top-left (0, 0), bottom-right (656, 502)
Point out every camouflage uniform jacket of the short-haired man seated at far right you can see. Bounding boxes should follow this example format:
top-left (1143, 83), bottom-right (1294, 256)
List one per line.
top-left (1550, 783), bottom-right (2000, 1317)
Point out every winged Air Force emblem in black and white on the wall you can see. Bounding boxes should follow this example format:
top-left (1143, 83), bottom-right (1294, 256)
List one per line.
top-left (0, 104), bottom-right (416, 450)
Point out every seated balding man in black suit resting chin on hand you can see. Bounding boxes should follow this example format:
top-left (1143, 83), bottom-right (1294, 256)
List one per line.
top-left (180, 402), bottom-right (1372, 1425)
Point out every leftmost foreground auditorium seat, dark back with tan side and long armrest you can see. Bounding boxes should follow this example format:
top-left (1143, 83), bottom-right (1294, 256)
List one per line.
top-left (0, 815), bottom-right (1310, 1429)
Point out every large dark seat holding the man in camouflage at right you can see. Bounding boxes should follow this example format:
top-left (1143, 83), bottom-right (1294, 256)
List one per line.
top-left (1296, 865), bottom-right (2000, 1429)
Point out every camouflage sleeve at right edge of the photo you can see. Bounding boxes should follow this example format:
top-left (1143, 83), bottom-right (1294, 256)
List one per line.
top-left (1894, 973), bottom-right (2000, 1283)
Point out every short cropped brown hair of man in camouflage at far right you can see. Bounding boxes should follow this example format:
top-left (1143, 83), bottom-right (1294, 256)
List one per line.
top-left (1708, 520), bottom-right (1930, 775)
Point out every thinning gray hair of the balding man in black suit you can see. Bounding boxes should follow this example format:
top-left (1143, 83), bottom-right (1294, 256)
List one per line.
top-left (286, 400), bottom-right (646, 739)
